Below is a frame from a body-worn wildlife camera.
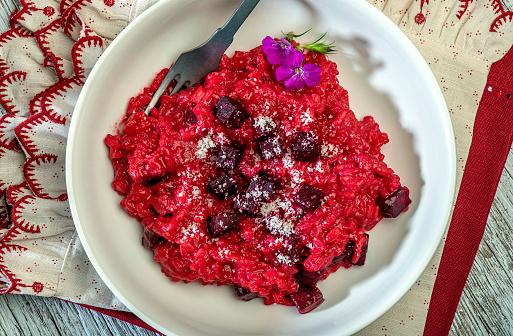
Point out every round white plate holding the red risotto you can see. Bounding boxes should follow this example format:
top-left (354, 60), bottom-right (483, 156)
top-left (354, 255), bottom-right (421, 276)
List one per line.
top-left (66, 0), bottom-right (456, 336)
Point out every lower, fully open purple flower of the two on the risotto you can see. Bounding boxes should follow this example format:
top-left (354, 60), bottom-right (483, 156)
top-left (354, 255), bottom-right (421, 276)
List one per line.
top-left (276, 53), bottom-right (321, 91)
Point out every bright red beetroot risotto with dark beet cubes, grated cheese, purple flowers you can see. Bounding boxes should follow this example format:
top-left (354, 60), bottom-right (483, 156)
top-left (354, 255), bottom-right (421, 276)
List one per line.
top-left (105, 33), bottom-right (411, 313)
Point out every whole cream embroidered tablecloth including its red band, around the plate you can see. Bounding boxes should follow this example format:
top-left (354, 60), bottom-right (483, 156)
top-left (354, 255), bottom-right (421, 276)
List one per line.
top-left (0, 0), bottom-right (513, 335)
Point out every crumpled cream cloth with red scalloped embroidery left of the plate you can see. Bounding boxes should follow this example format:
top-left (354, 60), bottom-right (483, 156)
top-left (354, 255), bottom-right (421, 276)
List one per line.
top-left (0, 0), bottom-right (156, 310)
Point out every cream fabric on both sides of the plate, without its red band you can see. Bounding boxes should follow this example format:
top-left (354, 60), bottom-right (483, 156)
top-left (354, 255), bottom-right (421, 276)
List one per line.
top-left (0, 0), bottom-right (513, 335)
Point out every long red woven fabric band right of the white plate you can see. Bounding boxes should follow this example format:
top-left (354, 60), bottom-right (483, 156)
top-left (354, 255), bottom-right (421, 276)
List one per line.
top-left (424, 45), bottom-right (513, 335)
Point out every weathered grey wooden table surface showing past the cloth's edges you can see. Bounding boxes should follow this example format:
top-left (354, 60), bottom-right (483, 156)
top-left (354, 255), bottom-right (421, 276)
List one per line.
top-left (0, 0), bottom-right (513, 336)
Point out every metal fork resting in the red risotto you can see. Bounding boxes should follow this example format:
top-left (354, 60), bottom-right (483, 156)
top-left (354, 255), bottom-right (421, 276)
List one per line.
top-left (144, 0), bottom-right (260, 115)
